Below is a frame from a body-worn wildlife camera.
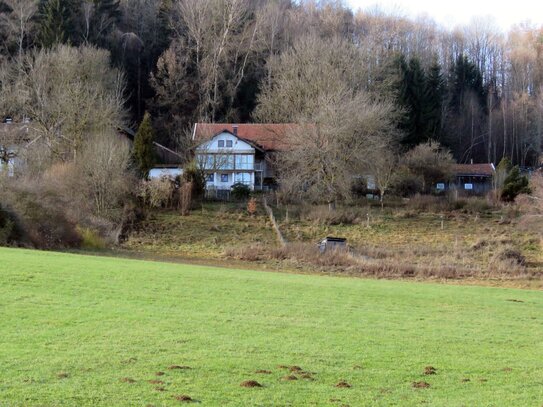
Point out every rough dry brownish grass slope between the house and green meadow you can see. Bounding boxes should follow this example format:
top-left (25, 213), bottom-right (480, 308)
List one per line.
top-left (124, 200), bottom-right (543, 281)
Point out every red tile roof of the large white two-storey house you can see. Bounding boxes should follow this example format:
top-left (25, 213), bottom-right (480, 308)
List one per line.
top-left (193, 123), bottom-right (297, 151)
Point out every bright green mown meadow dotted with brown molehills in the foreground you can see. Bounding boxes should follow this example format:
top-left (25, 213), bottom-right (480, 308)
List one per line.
top-left (0, 249), bottom-right (543, 407)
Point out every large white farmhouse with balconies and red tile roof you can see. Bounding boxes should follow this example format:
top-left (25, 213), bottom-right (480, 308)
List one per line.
top-left (192, 123), bottom-right (296, 191)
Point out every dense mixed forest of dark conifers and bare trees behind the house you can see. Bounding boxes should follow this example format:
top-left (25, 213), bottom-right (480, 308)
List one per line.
top-left (0, 0), bottom-right (543, 165)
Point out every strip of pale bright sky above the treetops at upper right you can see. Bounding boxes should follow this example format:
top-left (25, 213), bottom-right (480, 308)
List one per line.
top-left (346, 0), bottom-right (543, 31)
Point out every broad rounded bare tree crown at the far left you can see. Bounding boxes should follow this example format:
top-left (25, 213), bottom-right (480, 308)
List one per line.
top-left (0, 46), bottom-right (125, 160)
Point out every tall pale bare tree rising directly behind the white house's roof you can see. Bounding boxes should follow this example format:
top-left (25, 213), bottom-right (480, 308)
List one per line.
top-left (174, 0), bottom-right (258, 121)
